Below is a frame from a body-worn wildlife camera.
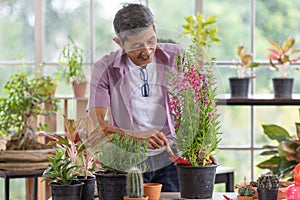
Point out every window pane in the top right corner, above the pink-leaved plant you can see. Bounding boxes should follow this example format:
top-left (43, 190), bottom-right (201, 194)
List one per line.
top-left (255, 0), bottom-right (300, 60)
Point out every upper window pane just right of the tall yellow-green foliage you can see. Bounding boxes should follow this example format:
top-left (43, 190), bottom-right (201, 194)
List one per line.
top-left (203, 0), bottom-right (250, 61)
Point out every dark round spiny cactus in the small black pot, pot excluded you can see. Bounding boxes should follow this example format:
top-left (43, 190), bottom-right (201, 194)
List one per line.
top-left (257, 172), bottom-right (279, 190)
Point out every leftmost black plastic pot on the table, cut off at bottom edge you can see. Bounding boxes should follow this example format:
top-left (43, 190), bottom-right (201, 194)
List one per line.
top-left (49, 182), bottom-right (83, 200)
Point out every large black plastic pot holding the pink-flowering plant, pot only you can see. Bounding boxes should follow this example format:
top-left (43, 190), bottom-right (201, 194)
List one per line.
top-left (177, 165), bottom-right (217, 199)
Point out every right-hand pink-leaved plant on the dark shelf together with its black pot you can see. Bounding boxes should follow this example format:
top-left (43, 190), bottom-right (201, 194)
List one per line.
top-left (267, 37), bottom-right (300, 98)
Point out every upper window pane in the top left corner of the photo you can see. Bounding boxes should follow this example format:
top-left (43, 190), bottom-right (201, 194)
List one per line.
top-left (0, 0), bottom-right (34, 61)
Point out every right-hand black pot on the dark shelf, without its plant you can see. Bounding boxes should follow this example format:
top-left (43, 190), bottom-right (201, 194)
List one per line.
top-left (272, 78), bottom-right (294, 98)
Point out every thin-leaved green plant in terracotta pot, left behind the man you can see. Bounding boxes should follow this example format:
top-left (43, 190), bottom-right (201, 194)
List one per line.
top-left (58, 36), bottom-right (87, 97)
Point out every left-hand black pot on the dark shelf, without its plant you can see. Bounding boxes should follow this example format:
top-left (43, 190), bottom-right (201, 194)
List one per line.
top-left (229, 78), bottom-right (250, 98)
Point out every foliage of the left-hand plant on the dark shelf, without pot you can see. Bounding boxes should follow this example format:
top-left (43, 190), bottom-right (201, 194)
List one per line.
top-left (235, 44), bottom-right (260, 78)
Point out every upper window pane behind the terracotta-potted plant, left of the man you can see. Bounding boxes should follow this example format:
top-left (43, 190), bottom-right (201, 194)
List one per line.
top-left (43, 0), bottom-right (90, 62)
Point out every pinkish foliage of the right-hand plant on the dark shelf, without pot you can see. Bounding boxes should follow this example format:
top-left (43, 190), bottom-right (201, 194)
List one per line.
top-left (267, 37), bottom-right (300, 78)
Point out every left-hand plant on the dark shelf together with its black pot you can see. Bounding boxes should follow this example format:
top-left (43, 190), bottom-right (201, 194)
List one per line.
top-left (229, 45), bottom-right (260, 98)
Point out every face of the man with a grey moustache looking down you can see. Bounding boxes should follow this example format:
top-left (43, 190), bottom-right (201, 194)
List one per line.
top-left (117, 27), bottom-right (156, 66)
